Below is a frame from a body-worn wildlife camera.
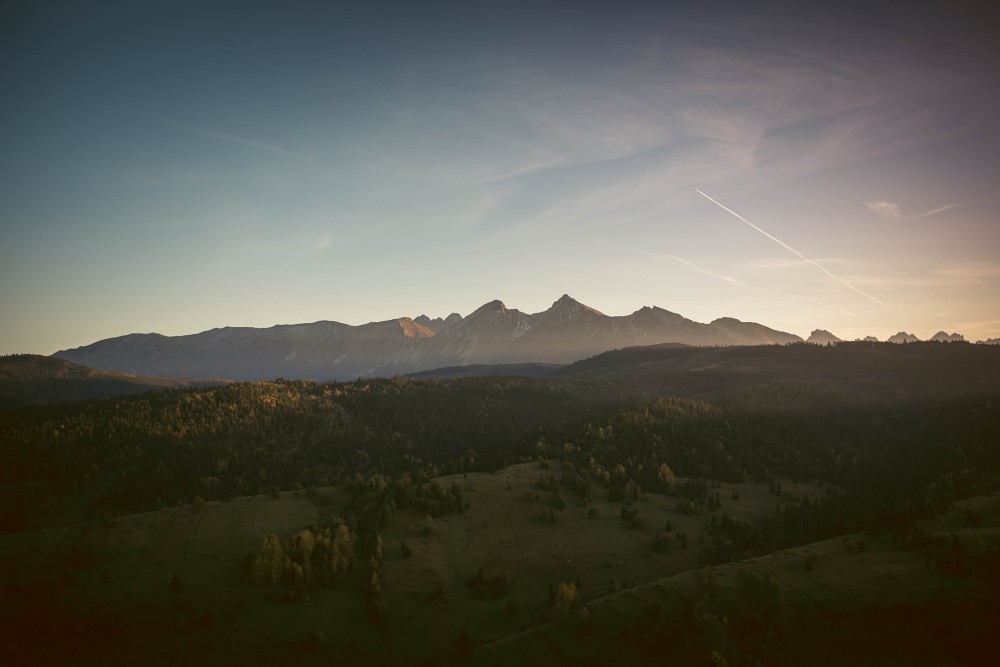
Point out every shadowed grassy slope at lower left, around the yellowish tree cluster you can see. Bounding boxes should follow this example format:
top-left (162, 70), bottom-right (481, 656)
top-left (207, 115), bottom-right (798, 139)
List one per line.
top-left (0, 488), bottom-right (396, 664)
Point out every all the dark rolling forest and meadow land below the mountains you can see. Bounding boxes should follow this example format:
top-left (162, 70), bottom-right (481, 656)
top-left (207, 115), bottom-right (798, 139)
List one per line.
top-left (0, 343), bottom-right (1000, 665)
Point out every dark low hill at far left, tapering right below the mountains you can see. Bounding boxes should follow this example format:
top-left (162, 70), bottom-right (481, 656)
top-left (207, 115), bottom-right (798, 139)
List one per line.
top-left (0, 354), bottom-right (225, 410)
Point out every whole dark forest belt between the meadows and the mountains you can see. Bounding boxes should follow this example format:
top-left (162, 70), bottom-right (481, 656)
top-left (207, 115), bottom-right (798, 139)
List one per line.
top-left (0, 344), bottom-right (1000, 530)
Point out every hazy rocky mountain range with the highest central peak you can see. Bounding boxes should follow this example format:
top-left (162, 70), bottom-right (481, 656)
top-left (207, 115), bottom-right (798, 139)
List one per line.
top-left (53, 295), bottom-right (802, 380)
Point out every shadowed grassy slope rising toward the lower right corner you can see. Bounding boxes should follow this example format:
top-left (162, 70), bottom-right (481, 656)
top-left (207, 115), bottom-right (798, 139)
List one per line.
top-left (472, 494), bottom-right (1000, 665)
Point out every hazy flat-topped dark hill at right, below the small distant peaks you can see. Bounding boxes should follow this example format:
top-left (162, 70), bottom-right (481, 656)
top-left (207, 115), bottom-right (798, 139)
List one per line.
top-left (550, 342), bottom-right (1000, 409)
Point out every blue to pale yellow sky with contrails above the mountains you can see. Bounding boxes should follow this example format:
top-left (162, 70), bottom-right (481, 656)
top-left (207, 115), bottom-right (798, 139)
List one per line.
top-left (0, 0), bottom-right (1000, 354)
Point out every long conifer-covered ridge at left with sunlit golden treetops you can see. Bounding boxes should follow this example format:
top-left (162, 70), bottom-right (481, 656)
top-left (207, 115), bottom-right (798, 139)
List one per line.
top-left (0, 377), bottom-right (607, 530)
